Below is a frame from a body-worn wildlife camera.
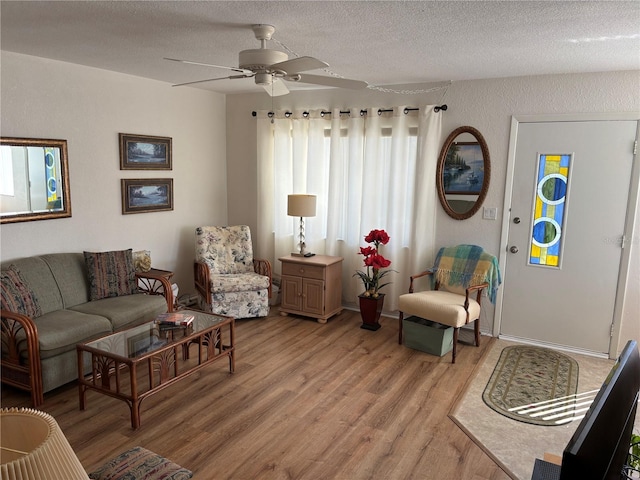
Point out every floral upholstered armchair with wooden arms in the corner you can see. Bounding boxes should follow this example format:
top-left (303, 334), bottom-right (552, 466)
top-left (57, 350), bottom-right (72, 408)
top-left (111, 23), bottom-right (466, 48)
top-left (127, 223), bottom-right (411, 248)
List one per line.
top-left (194, 225), bottom-right (271, 318)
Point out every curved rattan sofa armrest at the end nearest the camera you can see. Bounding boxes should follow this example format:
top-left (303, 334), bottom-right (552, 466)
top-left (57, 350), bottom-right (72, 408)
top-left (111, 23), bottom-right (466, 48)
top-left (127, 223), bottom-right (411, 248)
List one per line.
top-left (0, 310), bottom-right (44, 408)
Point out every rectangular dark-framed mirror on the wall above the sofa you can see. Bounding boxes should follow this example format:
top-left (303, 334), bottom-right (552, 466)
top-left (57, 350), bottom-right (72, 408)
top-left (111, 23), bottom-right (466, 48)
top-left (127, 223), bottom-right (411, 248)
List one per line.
top-left (0, 137), bottom-right (71, 223)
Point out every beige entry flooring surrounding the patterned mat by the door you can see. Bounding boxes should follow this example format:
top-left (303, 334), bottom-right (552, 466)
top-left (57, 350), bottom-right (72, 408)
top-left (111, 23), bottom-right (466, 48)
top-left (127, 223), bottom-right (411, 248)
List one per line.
top-left (449, 337), bottom-right (620, 480)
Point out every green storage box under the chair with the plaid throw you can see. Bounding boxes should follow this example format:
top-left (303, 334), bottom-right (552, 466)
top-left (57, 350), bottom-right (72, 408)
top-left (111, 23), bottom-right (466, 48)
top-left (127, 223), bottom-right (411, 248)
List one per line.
top-left (402, 316), bottom-right (453, 357)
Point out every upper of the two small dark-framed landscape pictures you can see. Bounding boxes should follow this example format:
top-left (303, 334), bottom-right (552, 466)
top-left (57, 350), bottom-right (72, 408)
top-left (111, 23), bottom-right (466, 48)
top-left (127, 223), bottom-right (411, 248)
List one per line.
top-left (119, 133), bottom-right (172, 170)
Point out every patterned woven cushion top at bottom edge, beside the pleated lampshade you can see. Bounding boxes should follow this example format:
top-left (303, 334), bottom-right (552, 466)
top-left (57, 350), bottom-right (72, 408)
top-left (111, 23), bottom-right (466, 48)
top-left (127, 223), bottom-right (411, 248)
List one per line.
top-left (89, 447), bottom-right (193, 480)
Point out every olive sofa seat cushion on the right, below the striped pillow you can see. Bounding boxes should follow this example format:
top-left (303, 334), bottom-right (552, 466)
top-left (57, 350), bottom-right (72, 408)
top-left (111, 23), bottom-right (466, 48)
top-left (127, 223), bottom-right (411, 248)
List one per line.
top-left (71, 293), bottom-right (167, 331)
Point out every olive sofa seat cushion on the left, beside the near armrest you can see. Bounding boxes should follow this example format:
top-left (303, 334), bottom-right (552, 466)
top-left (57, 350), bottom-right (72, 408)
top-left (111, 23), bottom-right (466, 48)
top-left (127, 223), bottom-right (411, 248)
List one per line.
top-left (34, 310), bottom-right (112, 359)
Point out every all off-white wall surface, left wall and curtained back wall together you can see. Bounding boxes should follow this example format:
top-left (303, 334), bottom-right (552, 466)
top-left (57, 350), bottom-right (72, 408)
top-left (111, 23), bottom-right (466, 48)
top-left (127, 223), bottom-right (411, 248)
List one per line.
top-left (0, 52), bottom-right (640, 352)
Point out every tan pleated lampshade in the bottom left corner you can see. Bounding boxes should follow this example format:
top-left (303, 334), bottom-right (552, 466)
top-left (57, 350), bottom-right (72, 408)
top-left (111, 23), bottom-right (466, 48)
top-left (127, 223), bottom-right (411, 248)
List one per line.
top-left (0, 408), bottom-right (89, 480)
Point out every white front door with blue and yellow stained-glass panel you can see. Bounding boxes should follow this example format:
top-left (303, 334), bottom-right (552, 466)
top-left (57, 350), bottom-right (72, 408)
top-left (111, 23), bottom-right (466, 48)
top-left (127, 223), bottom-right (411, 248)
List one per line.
top-left (500, 120), bottom-right (638, 353)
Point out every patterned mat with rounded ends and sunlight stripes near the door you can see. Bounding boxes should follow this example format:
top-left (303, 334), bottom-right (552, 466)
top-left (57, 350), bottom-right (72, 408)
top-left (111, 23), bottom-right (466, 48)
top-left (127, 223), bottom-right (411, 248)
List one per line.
top-left (482, 345), bottom-right (581, 426)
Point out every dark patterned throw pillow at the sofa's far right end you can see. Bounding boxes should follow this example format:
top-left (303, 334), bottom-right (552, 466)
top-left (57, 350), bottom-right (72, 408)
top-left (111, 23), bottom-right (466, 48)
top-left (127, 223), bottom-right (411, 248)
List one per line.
top-left (84, 249), bottom-right (138, 300)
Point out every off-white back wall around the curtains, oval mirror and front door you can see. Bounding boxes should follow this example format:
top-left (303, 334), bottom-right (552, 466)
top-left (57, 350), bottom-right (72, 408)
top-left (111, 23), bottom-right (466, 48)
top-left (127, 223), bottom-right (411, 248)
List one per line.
top-left (227, 71), bottom-right (640, 352)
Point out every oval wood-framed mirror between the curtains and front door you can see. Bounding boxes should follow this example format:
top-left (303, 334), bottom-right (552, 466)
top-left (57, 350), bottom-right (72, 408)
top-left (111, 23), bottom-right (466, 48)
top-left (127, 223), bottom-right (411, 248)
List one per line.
top-left (436, 126), bottom-right (491, 220)
